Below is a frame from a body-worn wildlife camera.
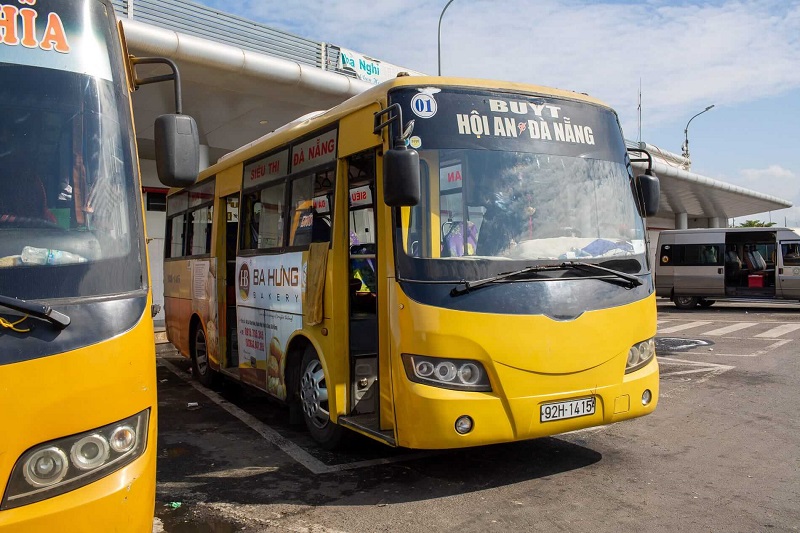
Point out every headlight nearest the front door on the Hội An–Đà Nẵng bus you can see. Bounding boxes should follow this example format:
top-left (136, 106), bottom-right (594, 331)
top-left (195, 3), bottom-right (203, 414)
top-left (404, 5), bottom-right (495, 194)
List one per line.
top-left (403, 353), bottom-right (492, 392)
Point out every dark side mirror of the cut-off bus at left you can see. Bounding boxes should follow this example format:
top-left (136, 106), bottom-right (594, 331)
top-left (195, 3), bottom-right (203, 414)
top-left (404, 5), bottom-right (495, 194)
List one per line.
top-left (154, 114), bottom-right (200, 187)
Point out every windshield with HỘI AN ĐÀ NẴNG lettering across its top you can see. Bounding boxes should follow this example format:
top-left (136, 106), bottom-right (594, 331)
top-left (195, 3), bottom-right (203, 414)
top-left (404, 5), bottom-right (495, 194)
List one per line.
top-left (396, 85), bottom-right (646, 280)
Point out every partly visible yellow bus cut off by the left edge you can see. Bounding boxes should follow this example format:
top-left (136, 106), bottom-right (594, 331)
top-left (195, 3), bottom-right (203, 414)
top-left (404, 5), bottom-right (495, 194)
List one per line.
top-left (0, 0), bottom-right (198, 533)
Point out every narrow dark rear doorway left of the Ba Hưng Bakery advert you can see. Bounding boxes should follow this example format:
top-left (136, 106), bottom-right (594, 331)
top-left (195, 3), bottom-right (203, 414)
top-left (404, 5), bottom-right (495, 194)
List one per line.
top-left (218, 192), bottom-right (239, 377)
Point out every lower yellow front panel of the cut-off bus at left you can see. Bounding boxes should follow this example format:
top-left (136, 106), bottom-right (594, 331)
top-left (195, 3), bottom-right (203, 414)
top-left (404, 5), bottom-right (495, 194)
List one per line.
top-left (0, 310), bottom-right (158, 533)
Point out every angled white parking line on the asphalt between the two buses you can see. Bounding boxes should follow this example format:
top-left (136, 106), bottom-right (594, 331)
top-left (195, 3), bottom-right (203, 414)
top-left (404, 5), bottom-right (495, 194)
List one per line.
top-left (158, 357), bottom-right (433, 474)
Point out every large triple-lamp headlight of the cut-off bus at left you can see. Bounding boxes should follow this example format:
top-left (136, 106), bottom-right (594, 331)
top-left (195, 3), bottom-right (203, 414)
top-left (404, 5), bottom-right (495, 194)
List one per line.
top-left (0, 409), bottom-right (150, 510)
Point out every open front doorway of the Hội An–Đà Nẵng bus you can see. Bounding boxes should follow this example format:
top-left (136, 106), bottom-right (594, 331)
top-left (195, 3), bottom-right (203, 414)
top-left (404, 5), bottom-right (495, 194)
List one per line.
top-left (344, 151), bottom-right (384, 440)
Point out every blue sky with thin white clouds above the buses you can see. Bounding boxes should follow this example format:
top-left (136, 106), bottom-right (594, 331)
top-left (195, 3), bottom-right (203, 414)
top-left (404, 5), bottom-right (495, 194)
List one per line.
top-left (195, 0), bottom-right (800, 227)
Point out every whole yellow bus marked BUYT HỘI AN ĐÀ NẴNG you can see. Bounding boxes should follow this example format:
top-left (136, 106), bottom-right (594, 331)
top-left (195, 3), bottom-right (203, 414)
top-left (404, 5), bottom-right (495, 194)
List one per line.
top-left (165, 76), bottom-right (659, 448)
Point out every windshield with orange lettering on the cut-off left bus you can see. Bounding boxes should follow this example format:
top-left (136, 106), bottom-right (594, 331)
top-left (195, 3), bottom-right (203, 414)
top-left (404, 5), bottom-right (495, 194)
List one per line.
top-left (0, 0), bottom-right (146, 299)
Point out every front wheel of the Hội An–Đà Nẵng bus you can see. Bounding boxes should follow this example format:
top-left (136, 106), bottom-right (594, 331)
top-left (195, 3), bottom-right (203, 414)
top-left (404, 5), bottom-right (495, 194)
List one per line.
top-left (300, 346), bottom-right (345, 450)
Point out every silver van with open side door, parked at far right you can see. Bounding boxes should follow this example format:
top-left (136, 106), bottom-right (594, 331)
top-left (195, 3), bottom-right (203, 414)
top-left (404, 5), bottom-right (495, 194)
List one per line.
top-left (655, 228), bottom-right (800, 309)
